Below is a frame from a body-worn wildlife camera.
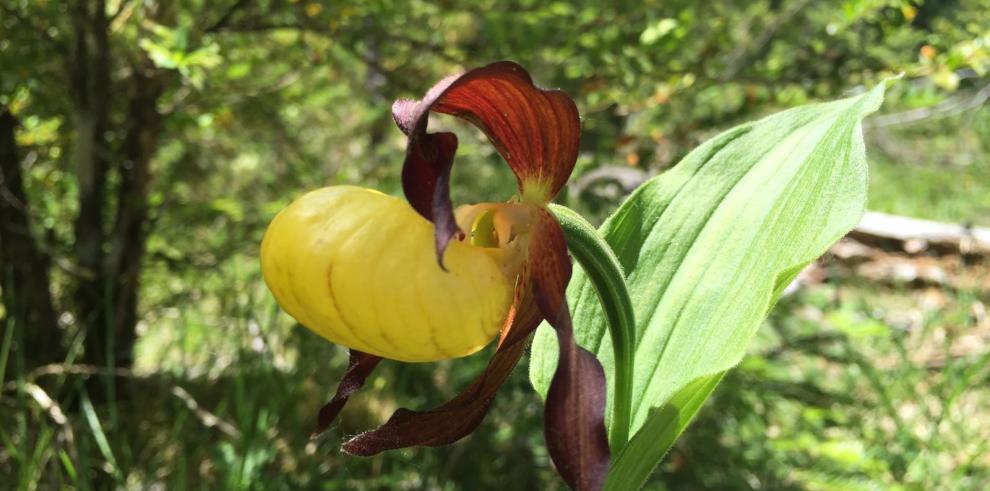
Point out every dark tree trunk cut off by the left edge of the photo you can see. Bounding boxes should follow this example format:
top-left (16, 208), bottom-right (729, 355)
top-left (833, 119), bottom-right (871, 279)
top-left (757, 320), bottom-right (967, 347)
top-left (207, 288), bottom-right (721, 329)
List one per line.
top-left (0, 108), bottom-right (64, 368)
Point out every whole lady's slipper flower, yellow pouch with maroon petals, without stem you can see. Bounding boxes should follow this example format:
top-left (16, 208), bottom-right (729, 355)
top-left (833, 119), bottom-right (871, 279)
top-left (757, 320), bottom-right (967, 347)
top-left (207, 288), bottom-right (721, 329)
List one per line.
top-left (262, 62), bottom-right (609, 489)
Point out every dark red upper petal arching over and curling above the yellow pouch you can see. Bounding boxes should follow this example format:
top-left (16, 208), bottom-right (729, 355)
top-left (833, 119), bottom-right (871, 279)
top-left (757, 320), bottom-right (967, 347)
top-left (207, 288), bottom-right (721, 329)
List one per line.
top-left (392, 61), bottom-right (581, 260)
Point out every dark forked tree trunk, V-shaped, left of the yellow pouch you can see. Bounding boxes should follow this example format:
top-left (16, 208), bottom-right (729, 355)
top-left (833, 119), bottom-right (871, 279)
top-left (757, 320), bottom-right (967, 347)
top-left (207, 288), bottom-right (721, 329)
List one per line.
top-left (68, 0), bottom-right (165, 367)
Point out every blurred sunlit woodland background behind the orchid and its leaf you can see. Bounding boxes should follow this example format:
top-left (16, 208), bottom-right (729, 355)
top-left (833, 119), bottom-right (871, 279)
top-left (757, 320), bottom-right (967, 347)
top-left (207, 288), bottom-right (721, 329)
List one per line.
top-left (0, 0), bottom-right (990, 490)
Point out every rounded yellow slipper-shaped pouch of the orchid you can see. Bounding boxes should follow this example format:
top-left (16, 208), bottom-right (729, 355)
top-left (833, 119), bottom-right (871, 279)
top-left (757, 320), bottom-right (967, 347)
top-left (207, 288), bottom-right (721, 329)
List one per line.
top-left (261, 186), bottom-right (515, 362)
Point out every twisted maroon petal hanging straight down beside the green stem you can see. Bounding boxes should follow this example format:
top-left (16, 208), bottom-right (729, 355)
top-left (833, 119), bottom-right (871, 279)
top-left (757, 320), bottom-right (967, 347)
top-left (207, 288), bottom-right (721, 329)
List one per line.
top-left (528, 212), bottom-right (611, 490)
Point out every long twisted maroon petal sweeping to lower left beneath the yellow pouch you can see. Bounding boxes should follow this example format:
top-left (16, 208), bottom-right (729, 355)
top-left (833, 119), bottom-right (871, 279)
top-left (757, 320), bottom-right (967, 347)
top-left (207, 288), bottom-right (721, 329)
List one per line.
top-left (343, 278), bottom-right (542, 456)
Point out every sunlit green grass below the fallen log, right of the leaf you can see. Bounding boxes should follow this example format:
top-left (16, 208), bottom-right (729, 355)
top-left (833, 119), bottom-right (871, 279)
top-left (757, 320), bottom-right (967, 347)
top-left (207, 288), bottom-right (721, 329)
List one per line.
top-left (657, 266), bottom-right (990, 491)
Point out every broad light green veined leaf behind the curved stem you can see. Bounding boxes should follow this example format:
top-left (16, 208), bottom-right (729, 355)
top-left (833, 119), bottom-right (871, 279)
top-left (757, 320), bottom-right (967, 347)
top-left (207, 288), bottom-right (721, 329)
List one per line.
top-left (530, 84), bottom-right (884, 485)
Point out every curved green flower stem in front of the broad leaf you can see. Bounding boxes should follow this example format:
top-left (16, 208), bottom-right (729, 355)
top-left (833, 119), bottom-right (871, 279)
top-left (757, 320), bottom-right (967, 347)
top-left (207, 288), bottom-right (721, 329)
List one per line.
top-left (550, 204), bottom-right (636, 455)
